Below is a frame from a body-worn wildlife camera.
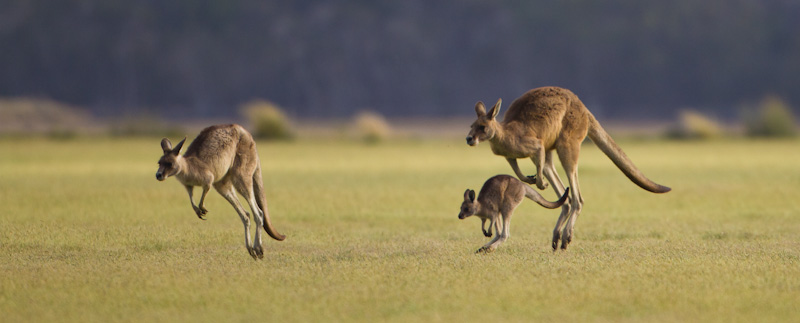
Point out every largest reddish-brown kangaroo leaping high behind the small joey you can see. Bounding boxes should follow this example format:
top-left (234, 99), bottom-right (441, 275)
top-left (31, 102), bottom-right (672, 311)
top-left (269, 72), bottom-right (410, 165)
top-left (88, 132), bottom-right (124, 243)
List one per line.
top-left (467, 87), bottom-right (670, 250)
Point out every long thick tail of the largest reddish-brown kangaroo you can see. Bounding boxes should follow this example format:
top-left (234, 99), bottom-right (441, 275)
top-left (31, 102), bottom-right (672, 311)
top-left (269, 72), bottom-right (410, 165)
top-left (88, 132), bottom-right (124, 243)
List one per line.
top-left (589, 117), bottom-right (672, 193)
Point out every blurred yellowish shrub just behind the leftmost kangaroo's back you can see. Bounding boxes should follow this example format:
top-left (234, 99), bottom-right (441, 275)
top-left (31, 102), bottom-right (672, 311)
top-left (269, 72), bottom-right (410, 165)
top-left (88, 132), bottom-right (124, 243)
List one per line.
top-left (240, 100), bottom-right (294, 140)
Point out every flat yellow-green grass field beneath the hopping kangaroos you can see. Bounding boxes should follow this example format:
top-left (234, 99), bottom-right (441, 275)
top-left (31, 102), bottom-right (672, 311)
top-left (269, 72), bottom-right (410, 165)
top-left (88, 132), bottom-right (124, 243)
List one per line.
top-left (0, 138), bottom-right (800, 322)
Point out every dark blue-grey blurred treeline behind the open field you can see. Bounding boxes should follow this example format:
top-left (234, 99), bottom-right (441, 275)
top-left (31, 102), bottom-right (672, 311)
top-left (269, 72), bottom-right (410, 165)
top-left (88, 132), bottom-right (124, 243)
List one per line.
top-left (0, 0), bottom-right (800, 119)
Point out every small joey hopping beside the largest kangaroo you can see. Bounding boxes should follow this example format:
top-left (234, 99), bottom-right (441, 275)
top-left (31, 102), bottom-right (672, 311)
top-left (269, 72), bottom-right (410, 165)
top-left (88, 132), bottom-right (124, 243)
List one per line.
top-left (458, 175), bottom-right (569, 253)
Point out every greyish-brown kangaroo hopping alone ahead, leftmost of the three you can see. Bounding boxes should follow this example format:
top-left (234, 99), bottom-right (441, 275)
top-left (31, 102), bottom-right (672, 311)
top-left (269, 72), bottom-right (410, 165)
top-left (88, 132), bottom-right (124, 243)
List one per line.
top-left (156, 124), bottom-right (286, 259)
